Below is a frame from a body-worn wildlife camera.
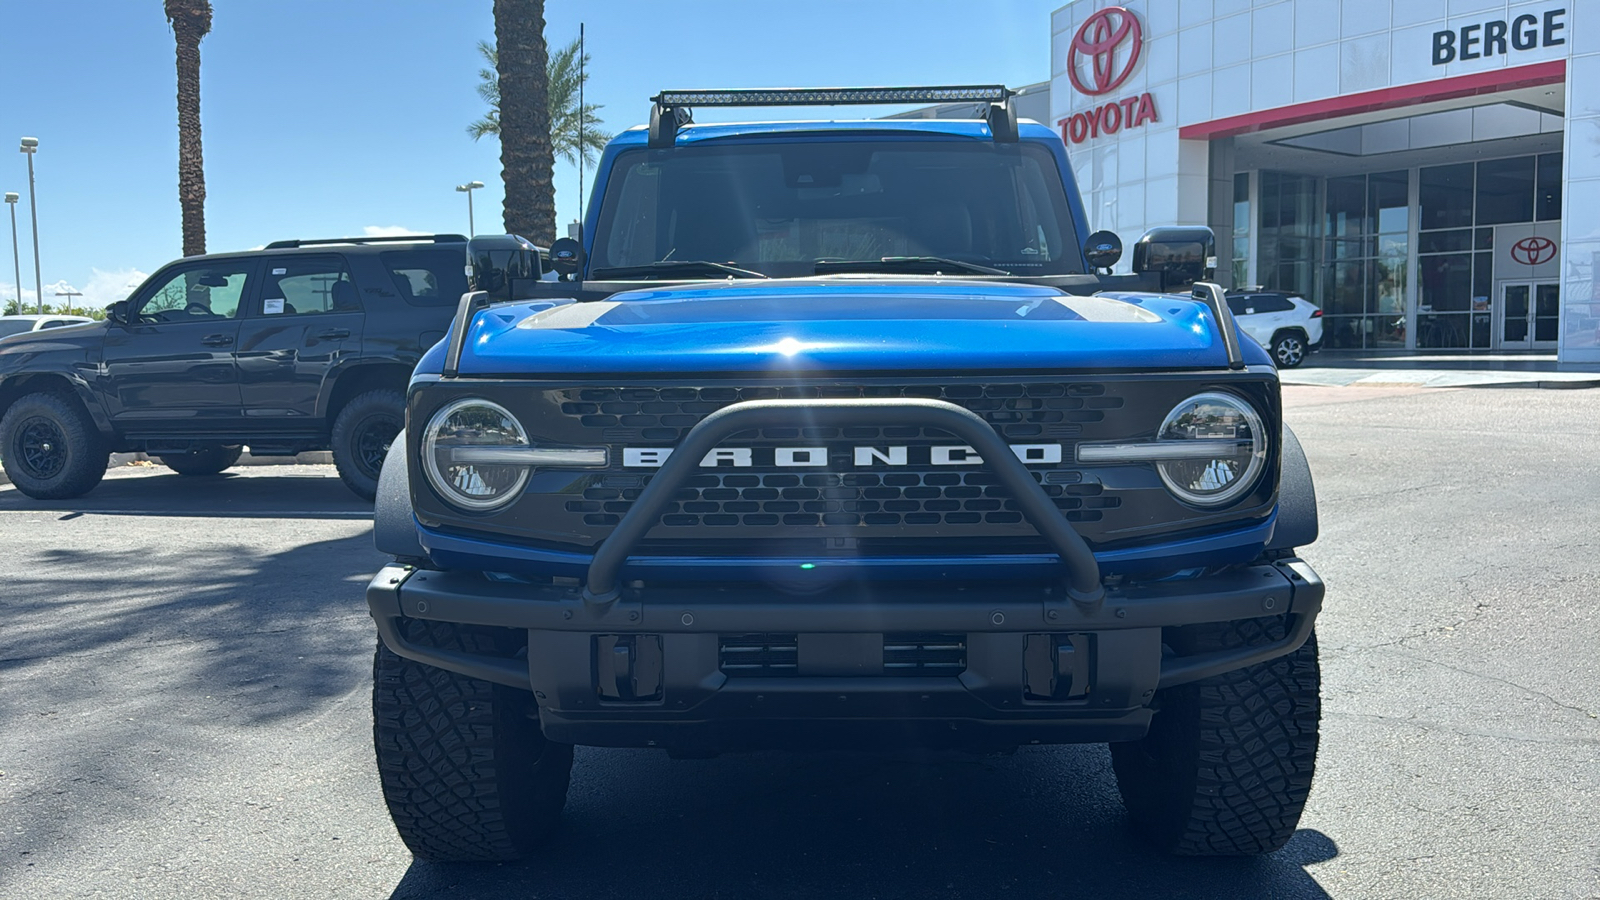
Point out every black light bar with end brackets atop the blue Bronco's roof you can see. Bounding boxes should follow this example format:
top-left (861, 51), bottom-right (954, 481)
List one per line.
top-left (650, 85), bottom-right (1018, 149)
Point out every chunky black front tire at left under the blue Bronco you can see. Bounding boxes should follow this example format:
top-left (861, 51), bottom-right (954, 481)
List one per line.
top-left (373, 620), bottom-right (573, 862)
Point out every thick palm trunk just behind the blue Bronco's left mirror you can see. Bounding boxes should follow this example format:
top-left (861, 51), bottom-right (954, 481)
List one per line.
top-left (494, 0), bottom-right (555, 245)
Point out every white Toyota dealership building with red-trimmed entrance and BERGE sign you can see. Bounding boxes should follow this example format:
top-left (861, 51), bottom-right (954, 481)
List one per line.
top-left (1050, 0), bottom-right (1600, 367)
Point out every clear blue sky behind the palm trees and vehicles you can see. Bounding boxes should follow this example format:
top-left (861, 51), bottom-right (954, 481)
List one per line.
top-left (0, 0), bottom-right (1066, 306)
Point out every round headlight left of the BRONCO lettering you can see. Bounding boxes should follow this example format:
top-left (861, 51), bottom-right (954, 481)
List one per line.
top-left (422, 399), bottom-right (528, 509)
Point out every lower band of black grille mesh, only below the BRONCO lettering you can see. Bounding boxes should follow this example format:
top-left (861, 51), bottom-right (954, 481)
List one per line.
top-left (566, 469), bottom-right (1122, 528)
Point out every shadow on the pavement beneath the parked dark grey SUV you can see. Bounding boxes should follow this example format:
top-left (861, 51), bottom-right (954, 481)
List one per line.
top-left (0, 466), bottom-right (373, 519)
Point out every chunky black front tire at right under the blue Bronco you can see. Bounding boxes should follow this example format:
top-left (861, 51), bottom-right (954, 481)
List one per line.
top-left (1110, 618), bottom-right (1322, 857)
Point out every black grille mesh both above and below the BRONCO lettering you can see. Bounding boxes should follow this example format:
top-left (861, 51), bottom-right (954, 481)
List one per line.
top-left (560, 381), bottom-right (1123, 528)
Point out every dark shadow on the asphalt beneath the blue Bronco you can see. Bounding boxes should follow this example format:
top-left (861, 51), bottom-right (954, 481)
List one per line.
top-left (390, 746), bottom-right (1339, 900)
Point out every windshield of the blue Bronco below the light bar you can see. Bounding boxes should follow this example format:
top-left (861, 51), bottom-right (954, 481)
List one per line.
top-left (589, 139), bottom-right (1083, 277)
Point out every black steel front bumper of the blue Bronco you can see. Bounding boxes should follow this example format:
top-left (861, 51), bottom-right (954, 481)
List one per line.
top-left (366, 559), bottom-right (1323, 753)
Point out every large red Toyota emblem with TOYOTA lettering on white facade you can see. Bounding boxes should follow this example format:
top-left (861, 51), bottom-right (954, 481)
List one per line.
top-left (1059, 6), bottom-right (1157, 144)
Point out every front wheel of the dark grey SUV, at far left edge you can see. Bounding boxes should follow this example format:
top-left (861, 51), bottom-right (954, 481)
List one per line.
top-left (0, 394), bottom-right (110, 500)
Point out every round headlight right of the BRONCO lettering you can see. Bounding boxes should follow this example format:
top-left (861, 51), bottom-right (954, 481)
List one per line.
top-left (1155, 394), bottom-right (1267, 506)
